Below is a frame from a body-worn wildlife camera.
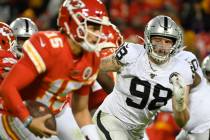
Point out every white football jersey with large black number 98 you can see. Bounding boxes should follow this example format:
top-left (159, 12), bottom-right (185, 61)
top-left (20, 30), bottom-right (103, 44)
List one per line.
top-left (99, 43), bottom-right (193, 129)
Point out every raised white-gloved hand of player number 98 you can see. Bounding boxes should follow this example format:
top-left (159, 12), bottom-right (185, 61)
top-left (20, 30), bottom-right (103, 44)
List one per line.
top-left (169, 73), bottom-right (186, 111)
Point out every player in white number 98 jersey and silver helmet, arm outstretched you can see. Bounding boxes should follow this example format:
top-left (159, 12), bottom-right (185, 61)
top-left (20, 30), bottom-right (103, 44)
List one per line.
top-left (93, 16), bottom-right (194, 140)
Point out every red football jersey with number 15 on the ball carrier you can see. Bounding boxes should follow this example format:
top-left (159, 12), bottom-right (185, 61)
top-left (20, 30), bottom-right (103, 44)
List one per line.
top-left (0, 31), bottom-right (100, 120)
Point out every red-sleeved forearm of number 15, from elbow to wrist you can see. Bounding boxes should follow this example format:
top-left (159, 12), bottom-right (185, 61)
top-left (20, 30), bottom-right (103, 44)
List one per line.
top-left (0, 84), bottom-right (29, 121)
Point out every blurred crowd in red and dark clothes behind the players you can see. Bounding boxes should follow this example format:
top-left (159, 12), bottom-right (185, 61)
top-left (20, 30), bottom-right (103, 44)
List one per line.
top-left (0, 0), bottom-right (210, 61)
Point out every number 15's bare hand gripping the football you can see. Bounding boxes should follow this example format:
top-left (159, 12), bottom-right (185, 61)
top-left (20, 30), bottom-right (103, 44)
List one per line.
top-left (28, 114), bottom-right (57, 138)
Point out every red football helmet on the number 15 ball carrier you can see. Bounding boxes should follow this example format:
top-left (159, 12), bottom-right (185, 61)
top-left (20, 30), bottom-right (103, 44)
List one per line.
top-left (57, 0), bottom-right (110, 51)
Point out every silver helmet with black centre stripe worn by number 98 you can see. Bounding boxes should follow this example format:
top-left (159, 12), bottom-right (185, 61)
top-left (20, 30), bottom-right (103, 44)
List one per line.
top-left (144, 16), bottom-right (184, 64)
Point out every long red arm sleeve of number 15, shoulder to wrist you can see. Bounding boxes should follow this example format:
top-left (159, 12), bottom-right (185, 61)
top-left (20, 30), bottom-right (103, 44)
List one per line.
top-left (0, 55), bottom-right (38, 121)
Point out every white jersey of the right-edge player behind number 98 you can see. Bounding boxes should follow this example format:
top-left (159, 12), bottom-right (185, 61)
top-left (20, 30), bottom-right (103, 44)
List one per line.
top-left (176, 51), bottom-right (210, 133)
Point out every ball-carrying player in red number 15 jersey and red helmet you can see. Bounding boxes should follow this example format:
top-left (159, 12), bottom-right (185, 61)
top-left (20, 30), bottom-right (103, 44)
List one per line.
top-left (0, 0), bottom-right (110, 140)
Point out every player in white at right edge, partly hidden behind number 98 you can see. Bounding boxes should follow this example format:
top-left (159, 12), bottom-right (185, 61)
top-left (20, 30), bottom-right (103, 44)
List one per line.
top-left (171, 51), bottom-right (210, 140)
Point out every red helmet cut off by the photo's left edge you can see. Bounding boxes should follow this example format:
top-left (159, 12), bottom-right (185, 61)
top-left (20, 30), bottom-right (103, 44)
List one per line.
top-left (0, 22), bottom-right (16, 50)
